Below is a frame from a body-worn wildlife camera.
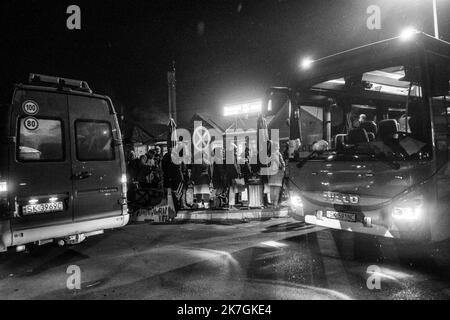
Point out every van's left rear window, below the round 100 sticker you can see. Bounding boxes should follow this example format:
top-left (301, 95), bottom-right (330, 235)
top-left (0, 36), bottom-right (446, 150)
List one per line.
top-left (17, 118), bottom-right (64, 161)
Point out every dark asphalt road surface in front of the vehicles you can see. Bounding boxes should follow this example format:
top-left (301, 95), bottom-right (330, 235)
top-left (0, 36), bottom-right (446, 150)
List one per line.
top-left (0, 218), bottom-right (450, 299)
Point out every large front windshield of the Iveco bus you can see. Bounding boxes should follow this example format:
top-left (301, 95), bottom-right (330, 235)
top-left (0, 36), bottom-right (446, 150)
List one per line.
top-left (293, 65), bottom-right (432, 160)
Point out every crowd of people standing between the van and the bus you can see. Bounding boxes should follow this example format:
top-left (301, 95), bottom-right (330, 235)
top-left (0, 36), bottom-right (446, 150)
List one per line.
top-left (127, 142), bottom-right (286, 211)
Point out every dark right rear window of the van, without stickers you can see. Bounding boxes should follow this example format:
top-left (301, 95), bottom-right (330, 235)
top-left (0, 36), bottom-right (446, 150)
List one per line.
top-left (75, 120), bottom-right (114, 161)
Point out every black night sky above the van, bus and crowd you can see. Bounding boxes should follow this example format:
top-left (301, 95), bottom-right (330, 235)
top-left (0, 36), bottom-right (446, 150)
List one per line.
top-left (0, 0), bottom-right (450, 127)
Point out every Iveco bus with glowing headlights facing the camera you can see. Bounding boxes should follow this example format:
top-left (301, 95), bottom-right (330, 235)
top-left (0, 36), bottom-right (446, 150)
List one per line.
top-left (266, 33), bottom-right (450, 240)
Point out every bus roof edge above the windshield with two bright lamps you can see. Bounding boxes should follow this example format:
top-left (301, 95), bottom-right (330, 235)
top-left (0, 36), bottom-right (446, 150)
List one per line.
top-left (291, 32), bottom-right (450, 88)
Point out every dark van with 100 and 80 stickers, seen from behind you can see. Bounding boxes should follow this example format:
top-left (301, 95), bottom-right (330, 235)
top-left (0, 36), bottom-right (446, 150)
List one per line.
top-left (0, 74), bottom-right (129, 251)
